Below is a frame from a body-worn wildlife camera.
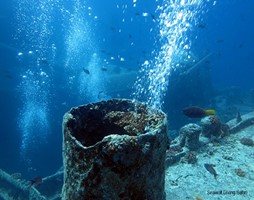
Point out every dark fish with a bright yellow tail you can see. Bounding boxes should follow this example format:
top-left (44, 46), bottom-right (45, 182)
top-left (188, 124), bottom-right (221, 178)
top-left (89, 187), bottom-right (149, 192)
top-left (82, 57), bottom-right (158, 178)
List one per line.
top-left (183, 106), bottom-right (215, 118)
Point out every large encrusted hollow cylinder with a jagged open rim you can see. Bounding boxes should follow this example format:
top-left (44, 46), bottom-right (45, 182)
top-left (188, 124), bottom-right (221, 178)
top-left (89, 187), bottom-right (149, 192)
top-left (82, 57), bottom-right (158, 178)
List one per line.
top-left (62, 99), bottom-right (168, 200)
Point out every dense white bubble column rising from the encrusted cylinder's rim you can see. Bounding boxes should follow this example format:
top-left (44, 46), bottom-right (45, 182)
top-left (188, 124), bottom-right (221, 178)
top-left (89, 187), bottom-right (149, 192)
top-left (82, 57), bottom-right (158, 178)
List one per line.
top-left (134, 0), bottom-right (203, 109)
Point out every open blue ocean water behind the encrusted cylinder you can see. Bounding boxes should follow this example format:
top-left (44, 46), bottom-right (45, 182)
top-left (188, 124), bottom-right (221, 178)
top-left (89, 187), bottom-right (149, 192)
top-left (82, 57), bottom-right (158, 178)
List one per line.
top-left (0, 0), bottom-right (254, 191)
